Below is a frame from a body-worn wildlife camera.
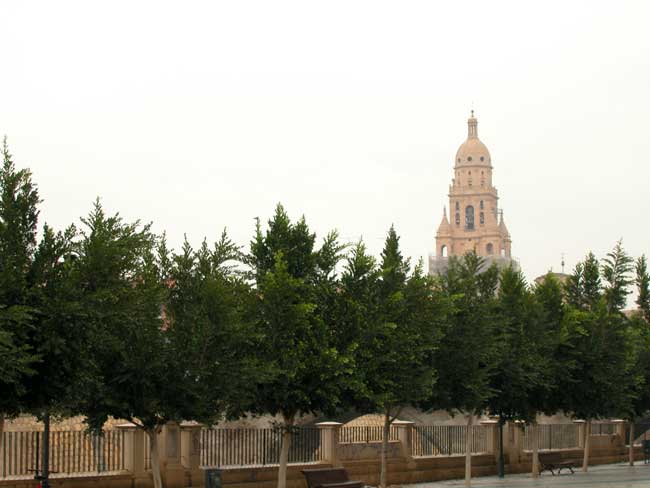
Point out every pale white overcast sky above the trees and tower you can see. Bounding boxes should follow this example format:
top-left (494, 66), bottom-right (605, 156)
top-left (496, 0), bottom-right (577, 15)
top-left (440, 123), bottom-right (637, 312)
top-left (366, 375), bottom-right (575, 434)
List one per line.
top-left (0, 0), bottom-right (650, 279)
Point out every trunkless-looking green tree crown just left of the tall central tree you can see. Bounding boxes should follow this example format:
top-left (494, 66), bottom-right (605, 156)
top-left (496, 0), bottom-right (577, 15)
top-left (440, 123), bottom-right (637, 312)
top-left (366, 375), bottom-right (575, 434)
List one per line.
top-left (165, 230), bottom-right (265, 424)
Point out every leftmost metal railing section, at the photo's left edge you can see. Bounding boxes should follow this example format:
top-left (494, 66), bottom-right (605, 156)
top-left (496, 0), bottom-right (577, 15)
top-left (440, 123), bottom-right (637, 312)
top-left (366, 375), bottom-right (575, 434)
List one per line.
top-left (0, 430), bottom-right (125, 478)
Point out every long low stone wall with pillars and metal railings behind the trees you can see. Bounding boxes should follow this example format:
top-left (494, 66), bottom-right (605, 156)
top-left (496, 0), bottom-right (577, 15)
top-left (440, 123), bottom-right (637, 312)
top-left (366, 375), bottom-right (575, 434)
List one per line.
top-left (0, 421), bottom-right (643, 488)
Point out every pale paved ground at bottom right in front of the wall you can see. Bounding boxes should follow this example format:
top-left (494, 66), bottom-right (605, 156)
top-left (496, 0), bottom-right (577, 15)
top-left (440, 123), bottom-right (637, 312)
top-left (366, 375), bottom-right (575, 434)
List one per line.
top-left (404, 463), bottom-right (650, 488)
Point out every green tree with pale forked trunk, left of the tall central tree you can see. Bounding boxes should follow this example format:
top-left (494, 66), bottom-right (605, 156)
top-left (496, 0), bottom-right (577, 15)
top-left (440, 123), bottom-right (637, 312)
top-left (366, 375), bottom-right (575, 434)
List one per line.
top-left (70, 201), bottom-right (170, 488)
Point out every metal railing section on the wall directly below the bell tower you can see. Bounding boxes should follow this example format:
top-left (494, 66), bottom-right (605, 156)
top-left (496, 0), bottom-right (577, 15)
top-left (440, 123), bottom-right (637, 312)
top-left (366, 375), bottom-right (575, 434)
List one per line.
top-left (412, 425), bottom-right (491, 457)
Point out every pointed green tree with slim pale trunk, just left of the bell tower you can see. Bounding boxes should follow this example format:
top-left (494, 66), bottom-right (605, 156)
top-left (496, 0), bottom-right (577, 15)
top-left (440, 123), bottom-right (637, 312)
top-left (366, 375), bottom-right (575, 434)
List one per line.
top-left (350, 227), bottom-right (446, 487)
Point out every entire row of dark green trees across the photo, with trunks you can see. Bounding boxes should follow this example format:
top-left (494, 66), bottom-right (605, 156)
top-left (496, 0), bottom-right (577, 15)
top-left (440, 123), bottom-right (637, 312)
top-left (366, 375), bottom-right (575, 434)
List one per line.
top-left (0, 143), bottom-right (650, 488)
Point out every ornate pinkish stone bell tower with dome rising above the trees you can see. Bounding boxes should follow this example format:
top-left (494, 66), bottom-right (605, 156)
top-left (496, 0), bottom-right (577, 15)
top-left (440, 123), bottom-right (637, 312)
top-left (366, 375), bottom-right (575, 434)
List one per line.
top-left (429, 110), bottom-right (512, 274)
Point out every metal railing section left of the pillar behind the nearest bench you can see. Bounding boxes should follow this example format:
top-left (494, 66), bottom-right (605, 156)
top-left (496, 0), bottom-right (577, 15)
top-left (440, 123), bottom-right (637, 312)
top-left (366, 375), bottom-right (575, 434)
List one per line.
top-left (201, 427), bottom-right (322, 467)
